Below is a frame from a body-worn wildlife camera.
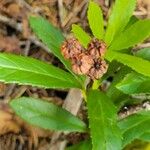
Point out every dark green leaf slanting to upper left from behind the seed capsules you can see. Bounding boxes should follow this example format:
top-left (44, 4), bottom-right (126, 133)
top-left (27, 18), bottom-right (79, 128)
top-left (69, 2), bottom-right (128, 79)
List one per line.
top-left (29, 16), bottom-right (85, 84)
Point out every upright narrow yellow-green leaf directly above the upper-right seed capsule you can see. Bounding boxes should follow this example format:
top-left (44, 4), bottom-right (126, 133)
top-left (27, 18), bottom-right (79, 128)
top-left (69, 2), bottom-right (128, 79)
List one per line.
top-left (87, 1), bottom-right (104, 39)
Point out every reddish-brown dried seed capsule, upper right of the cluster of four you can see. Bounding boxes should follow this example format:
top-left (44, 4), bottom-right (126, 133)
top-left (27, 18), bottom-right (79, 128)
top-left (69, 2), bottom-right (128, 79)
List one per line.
top-left (87, 38), bottom-right (106, 59)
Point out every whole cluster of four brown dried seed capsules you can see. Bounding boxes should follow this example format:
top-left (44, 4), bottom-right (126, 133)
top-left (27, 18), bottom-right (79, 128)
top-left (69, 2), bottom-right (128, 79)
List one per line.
top-left (61, 38), bottom-right (108, 80)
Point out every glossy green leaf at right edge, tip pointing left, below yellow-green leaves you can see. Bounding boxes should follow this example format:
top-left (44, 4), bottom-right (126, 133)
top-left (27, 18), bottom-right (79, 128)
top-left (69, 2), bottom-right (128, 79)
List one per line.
top-left (116, 72), bottom-right (150, 94)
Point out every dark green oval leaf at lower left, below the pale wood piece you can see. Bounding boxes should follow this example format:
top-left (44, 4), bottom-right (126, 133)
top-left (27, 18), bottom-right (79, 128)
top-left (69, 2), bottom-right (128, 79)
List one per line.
top-left (10, 97), bottom-right (86, 132)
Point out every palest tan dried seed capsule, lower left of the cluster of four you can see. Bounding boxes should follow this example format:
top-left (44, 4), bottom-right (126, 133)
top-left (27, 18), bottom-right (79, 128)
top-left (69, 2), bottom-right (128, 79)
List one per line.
top-left (72, 53), bottom-right (94, 74)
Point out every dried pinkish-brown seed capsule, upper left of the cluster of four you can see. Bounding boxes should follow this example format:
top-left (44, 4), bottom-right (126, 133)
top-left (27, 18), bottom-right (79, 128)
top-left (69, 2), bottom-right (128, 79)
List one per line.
top-left (61, 38), bottom-right (84, 59)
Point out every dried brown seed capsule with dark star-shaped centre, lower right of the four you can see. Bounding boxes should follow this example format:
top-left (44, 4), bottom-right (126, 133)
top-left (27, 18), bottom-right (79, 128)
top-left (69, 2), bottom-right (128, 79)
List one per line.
top-left (87, 59), bottom-right (108, 80)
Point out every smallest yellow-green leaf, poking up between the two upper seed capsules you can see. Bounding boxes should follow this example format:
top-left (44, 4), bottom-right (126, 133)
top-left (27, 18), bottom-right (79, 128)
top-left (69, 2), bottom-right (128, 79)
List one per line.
top-left (72, 24), bottom-right (91, 48)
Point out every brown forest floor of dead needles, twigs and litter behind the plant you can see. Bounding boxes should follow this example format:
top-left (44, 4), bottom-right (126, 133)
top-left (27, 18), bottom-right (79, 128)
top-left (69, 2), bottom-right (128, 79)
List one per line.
top-left (0, 0), bottom-right (150, 150)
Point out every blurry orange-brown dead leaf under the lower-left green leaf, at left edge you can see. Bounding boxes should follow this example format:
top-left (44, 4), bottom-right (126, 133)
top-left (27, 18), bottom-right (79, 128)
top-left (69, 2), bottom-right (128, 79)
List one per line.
top-left (0, 102), bottom-right (51, 147)
